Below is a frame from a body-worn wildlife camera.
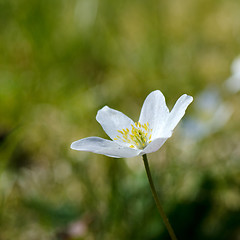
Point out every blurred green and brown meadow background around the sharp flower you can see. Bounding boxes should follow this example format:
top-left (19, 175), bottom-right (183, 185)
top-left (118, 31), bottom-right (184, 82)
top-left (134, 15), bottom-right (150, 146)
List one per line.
top-left (0, 0), bottom-right (240, 240)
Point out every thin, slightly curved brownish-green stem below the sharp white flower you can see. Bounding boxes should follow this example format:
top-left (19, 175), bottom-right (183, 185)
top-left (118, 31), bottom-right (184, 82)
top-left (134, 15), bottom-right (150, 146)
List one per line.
top-left (143, 154), bottom-right (177, 240)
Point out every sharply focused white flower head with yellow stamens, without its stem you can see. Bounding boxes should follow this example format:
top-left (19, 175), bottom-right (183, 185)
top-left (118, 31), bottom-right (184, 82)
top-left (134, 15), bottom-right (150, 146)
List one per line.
top-left (71, 90), bottom-right (193, 158)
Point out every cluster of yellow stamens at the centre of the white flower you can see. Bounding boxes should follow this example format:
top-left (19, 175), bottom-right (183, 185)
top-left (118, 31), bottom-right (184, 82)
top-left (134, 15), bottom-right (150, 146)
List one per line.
top-left (114, 122), bottom-right (152, 149)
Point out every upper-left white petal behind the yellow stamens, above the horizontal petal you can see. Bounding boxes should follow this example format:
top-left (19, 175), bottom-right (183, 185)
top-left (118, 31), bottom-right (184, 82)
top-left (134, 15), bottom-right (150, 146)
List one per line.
top-left (96, 106), bottom-right (134, 146)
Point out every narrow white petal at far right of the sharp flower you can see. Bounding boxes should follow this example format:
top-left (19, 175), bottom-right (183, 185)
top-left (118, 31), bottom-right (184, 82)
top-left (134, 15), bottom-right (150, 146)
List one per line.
top-left (164, 94), bottom-right (193, 133)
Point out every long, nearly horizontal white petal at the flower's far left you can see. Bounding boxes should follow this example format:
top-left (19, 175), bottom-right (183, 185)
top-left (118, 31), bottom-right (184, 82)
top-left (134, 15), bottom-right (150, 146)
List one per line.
top-left (71, 137), bottom-right (140, 158)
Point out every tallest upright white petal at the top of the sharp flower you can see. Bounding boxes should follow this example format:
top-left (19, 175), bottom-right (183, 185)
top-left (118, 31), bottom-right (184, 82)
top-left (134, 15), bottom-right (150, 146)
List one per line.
top-left (139, 90), bottom-right (169, 139)
